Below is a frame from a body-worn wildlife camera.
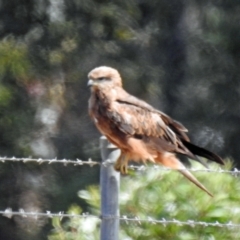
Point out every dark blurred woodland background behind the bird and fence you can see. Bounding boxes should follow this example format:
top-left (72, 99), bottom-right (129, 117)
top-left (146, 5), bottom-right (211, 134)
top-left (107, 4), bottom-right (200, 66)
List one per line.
top-left (0, 0), bottom-right (240, 240)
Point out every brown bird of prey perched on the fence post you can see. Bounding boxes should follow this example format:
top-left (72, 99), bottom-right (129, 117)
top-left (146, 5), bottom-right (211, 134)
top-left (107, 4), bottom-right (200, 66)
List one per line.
top-left (88, 66), bottom-right (224, 196)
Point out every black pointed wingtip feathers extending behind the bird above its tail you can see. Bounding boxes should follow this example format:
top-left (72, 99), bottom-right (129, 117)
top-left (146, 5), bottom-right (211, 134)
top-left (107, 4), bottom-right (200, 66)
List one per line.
top-left (182, 140), bottom-right (224, 165)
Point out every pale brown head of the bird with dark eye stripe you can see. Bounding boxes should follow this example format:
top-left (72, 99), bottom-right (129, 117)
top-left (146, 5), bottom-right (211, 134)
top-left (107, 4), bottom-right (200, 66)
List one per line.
top-left (88, 66), bottom-right (122, 88)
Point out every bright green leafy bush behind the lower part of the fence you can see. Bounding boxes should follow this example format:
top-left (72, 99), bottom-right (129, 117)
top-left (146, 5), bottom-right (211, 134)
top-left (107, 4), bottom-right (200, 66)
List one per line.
top-left (49, 162), bottom-right (240, 240)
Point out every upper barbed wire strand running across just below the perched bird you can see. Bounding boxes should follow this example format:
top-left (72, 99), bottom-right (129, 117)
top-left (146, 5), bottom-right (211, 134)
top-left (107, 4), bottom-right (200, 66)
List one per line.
top-left (0, 157), bottom-right (240, 176)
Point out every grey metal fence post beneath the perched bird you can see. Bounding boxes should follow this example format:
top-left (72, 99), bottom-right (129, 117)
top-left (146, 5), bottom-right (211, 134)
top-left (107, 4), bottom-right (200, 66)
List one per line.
top-left (100, 136), bottom-right (120, 240)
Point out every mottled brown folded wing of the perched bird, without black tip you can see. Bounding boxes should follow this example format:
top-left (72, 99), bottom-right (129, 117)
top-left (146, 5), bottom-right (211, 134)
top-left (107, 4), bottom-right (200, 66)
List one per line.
top-left (105, 89), bottom-right (189, 145)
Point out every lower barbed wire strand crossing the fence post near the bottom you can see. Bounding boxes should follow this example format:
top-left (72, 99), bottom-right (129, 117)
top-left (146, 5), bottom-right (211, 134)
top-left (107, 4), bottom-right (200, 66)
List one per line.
top-left (0, 208), bottom-right (240, 228)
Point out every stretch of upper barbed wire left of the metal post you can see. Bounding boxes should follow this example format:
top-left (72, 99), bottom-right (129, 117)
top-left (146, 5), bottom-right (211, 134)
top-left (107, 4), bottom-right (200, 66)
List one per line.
top-left (0, 157), bottom-right (100, 167)
